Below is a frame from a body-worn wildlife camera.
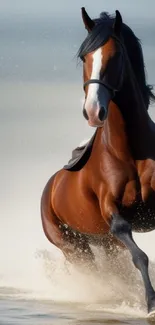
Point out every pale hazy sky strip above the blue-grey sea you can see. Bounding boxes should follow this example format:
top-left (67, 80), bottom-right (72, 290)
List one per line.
top-left (0, 0), bottom-right (155, 19)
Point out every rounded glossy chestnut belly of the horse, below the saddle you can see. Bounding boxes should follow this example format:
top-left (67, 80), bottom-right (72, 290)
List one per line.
top-left (52, 171), bottom-right (109, 234)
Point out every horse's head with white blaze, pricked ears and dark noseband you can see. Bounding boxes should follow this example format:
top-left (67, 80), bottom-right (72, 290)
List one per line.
top-left (80, 8), bottom-right (125, 127)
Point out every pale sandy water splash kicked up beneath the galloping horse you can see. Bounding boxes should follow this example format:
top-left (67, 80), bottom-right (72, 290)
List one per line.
top-left (1, 242), bottom-right (155, 317)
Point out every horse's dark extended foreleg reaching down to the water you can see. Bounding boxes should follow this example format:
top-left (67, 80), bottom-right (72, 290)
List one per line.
top-left (110, 214), bottom-right (155, 313)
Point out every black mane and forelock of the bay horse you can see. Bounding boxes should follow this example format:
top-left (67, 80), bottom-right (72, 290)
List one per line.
top-left (77, 12), bottom-right (155, 109)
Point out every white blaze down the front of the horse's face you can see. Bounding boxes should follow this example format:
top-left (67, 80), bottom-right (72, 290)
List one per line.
top-left (85, 48), bottom-right (102, 114)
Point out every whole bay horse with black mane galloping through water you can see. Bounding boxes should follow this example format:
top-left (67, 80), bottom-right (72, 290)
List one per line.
top-left (41, 8), bottom-right (155, 315)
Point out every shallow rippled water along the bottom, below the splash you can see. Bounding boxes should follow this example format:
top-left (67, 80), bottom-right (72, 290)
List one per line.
top-left (0, 299), bottom-right (151, 325)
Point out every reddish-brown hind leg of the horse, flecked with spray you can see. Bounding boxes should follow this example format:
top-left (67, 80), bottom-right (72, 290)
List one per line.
top-left (41, 175), bottom-right (94, 264)
